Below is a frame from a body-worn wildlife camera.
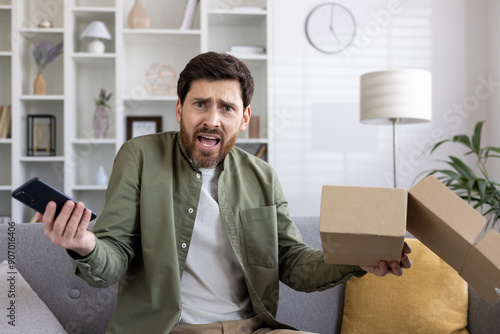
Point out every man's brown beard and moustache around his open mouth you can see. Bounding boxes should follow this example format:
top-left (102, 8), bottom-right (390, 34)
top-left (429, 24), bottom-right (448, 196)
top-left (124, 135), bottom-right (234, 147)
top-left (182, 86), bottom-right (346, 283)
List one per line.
top-left (181, 116), bottom-right (238, 168)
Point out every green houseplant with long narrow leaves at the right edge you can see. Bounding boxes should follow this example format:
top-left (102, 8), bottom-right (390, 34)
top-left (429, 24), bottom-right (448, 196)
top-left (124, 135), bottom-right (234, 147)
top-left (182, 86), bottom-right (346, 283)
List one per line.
top-left (430, 121), bottom-right (500, 227)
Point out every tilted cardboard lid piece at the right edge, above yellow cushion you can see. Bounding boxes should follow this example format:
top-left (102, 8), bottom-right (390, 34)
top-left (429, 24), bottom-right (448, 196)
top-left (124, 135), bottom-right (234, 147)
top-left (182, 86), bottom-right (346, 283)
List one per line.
top-left (407, 176), bottom-right (500, 305)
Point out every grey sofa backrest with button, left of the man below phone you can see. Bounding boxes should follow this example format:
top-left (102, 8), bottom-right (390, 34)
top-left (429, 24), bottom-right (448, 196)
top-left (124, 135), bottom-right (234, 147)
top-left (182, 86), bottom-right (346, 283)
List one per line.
top-left (0, 224), bottom-right (117, 334)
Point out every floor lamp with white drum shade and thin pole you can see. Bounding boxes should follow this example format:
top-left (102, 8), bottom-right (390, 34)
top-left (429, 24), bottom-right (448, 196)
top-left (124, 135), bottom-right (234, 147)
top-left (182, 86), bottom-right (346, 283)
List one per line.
top-left (360, 69), bottom-right (432, 188)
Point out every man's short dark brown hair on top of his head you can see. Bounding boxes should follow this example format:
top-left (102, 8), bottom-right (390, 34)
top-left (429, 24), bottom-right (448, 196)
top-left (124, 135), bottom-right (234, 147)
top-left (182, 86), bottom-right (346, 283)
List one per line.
top-left (177, 52), bottom-right (254, 108)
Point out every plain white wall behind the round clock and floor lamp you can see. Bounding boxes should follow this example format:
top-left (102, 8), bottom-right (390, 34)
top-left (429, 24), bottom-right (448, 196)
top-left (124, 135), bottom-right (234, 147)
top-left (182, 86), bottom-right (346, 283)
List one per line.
top-left (272, 0), bottom-right (492, 215)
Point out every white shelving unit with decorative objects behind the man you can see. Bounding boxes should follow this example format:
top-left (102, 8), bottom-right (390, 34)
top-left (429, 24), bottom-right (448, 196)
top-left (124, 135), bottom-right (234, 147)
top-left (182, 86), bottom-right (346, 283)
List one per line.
top-left (0, 0), bottom-right (273, 222)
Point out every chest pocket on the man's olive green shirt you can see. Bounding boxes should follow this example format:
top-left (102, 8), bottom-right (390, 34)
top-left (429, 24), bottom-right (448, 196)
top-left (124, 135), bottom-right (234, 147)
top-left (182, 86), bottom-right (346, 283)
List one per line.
top-left (240, 205), bottom-right (278, 268)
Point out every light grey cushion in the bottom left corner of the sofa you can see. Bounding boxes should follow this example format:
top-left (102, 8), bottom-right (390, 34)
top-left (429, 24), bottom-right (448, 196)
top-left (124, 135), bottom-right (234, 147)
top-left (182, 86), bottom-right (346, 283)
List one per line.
top-left (0, 261), bottom-right (66, 333)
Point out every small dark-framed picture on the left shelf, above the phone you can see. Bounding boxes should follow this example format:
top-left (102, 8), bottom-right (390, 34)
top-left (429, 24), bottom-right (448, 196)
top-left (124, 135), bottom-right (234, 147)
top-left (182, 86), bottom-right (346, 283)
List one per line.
top-left (27, 115), bottom-right (56, 156)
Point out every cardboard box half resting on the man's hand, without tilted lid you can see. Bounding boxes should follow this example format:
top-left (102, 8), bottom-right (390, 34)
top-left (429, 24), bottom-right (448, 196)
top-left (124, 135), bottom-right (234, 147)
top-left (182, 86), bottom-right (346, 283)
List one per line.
top-left (319, 186), bottom-right (408, 266)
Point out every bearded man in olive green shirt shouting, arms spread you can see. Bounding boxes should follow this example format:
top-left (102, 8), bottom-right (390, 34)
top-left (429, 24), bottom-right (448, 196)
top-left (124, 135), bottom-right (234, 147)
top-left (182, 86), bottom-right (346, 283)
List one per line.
top-left (42, 52), bottom-right (411, 333)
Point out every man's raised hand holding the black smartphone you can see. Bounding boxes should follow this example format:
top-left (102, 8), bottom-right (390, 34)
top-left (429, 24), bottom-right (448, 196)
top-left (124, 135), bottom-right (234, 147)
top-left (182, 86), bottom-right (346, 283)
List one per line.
top-left (38, 200), bottom-right (96, 257)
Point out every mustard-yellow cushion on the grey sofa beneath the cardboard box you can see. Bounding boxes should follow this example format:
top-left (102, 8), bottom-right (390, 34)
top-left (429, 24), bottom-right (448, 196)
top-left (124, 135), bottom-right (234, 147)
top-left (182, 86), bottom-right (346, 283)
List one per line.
top-left (341, 239), bottom-right (468, 334)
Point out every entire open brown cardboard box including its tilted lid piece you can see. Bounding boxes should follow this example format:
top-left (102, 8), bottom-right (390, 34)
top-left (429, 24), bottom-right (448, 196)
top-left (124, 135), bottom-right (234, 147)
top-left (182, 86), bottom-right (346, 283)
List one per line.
top-left (320, 176), bottom-right (500, 305)
